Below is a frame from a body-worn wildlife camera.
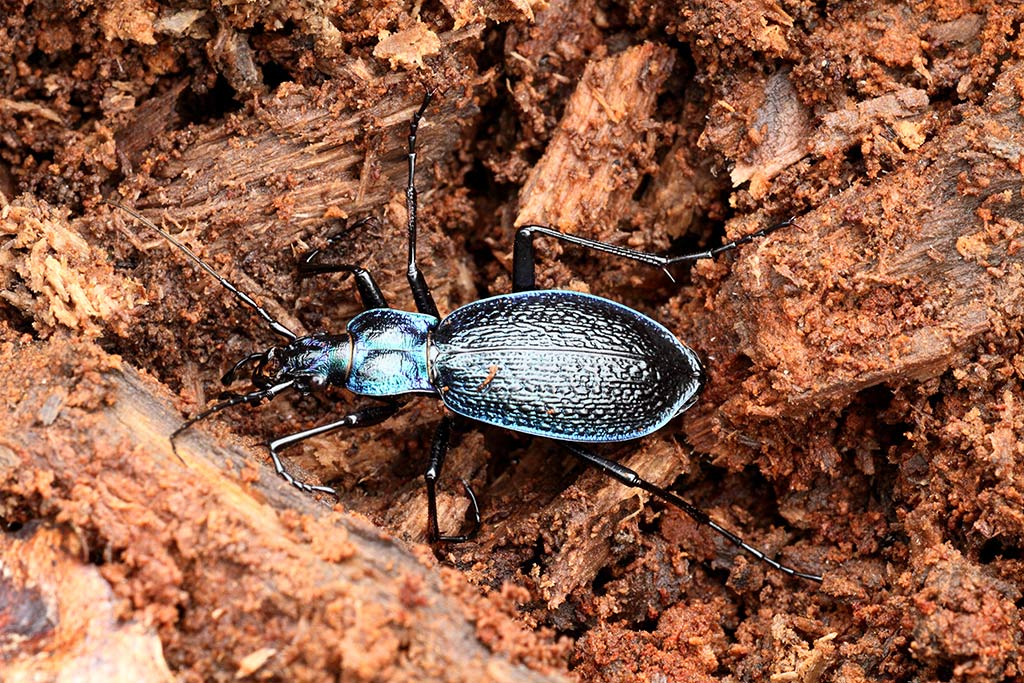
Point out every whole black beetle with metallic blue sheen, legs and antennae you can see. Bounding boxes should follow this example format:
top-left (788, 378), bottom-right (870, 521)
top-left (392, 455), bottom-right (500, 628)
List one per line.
top-left (111, 92), bottom-right (822, 583)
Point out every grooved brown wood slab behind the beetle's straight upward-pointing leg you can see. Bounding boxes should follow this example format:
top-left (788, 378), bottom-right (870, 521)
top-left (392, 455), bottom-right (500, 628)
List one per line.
top-left (131, 81), bottom-right (471, 282)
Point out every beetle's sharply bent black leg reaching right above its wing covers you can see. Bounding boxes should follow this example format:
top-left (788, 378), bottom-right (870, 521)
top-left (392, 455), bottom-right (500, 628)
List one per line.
top-left (512, 218), bottom-right (794, 292)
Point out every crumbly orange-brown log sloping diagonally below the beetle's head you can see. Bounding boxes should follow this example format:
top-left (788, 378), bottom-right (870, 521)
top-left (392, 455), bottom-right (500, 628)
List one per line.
top-left (0, 341), bottom-right (561, 681)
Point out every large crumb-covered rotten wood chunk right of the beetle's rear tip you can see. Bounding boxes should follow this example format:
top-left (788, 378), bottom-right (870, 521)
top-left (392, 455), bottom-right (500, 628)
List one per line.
top-left (690, 61), bottom-right (1024, 438)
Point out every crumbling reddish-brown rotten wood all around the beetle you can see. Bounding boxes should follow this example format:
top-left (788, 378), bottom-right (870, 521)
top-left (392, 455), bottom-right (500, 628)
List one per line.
top-left (0, 0), bottom-right (1024, 683)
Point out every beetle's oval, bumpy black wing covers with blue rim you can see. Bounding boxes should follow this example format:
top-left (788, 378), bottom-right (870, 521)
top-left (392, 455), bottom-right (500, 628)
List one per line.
top-left (432, 291), bottom-right (703, 442)
